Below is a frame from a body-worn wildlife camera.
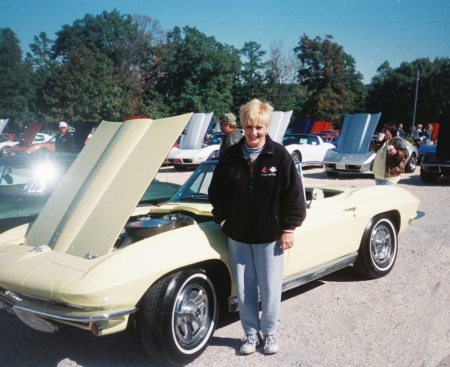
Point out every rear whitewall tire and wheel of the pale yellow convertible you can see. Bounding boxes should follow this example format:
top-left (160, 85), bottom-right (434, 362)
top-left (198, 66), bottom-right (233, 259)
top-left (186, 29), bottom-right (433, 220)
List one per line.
top-left (353, 214), bottom-right (398, 279)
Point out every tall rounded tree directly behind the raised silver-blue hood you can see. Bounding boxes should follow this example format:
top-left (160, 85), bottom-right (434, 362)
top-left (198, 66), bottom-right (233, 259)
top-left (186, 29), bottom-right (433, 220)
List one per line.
top-left (294, 35), bottom-right (365, 124)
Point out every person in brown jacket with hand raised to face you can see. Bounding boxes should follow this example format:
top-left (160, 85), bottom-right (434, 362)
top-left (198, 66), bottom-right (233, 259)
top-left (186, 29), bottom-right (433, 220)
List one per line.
top-left (370, 124), bottom-right (409, 185)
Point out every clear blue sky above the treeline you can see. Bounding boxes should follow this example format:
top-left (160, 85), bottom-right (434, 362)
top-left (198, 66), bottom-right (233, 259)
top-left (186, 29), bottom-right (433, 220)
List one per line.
top-left (0, 0), bottom-right (450, 83)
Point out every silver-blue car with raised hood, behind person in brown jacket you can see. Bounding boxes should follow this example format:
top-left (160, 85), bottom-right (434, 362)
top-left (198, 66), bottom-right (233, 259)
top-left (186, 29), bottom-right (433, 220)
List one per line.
top-left (323, 113), bottom-right (418, 177)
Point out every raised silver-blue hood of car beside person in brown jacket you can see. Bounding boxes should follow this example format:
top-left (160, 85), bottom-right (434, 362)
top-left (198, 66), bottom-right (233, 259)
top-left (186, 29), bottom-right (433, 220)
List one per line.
top-left (337, 113), bottom-right (381, 154)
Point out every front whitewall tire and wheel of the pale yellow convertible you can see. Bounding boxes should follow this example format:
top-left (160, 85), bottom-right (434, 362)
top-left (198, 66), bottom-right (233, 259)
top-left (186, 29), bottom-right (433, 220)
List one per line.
top-left (141, 269), bottom-right (219, 366)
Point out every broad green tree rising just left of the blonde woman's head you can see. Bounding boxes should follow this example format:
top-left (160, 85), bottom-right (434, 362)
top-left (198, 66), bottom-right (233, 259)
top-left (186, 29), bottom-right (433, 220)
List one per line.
top-left (156, 27), bottom-right (240, 114)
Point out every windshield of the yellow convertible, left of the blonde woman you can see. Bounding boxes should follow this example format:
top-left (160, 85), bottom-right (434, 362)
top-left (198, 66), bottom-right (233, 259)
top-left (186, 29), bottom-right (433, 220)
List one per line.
top-left (171, 162), bottom-right (217, 202)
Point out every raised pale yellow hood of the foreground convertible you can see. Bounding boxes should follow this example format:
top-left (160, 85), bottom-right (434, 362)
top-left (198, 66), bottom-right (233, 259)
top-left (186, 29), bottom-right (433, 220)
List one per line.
top-left (25, 114), bottom-right (192, 258)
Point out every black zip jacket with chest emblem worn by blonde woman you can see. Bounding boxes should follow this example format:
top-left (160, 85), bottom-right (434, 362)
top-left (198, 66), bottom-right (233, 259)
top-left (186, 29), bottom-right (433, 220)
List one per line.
top-left (208, 135), bottom-right (306, 244)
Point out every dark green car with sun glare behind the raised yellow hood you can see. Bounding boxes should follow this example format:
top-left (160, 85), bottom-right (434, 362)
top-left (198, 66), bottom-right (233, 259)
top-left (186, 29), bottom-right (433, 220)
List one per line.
top-left (0, 153), bottom-right (180, 233)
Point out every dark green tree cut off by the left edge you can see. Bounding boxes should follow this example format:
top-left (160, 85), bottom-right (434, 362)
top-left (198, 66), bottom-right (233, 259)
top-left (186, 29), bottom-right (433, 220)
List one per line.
top-left (0, 28), bottom-right (33, 125)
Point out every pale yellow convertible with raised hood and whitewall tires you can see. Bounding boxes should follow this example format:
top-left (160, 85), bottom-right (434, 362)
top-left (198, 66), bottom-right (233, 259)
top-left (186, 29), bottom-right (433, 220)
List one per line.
top-left (0, 114), bottom-right (419, 365)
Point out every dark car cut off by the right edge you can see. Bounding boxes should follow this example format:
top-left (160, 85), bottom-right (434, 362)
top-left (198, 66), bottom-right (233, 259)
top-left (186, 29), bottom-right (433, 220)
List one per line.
top-left (419, 124), bottom-right (450, 183)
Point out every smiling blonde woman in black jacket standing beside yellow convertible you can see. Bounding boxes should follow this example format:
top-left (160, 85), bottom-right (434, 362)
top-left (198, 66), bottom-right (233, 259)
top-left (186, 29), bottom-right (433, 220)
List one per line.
top-left (209, 99), bottom-right (306, 354)
